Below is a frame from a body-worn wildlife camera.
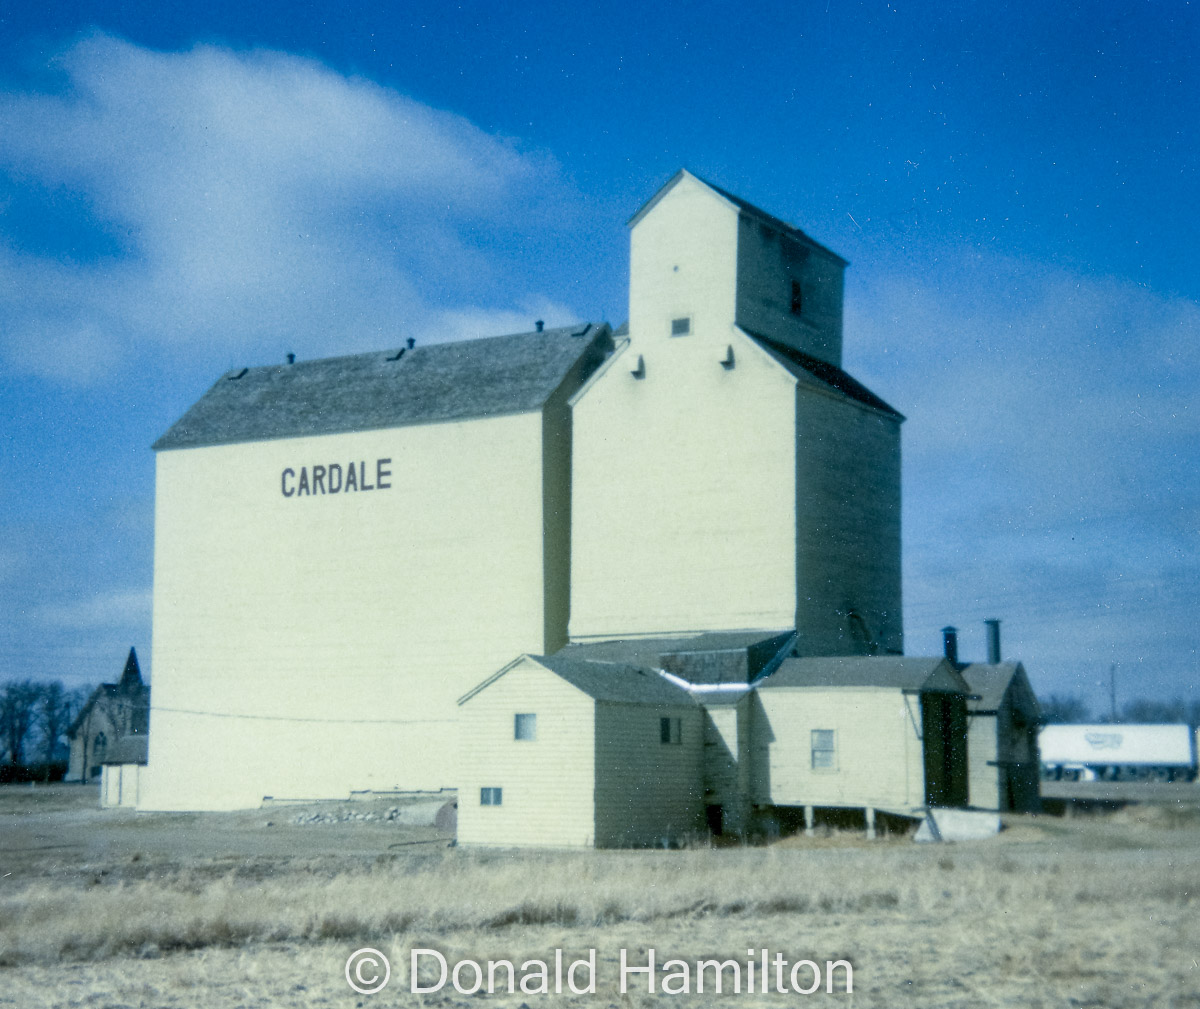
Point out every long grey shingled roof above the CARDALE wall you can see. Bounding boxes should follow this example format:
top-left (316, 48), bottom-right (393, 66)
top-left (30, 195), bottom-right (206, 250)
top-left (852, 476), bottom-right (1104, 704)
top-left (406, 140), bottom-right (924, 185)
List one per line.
top-left (154, 323), bottom-right (612, 451)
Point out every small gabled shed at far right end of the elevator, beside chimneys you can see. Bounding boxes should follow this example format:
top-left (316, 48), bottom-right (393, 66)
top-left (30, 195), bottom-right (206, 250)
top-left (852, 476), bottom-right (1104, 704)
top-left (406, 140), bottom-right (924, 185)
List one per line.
top-left (962, 662), bottom-right (1042, 812)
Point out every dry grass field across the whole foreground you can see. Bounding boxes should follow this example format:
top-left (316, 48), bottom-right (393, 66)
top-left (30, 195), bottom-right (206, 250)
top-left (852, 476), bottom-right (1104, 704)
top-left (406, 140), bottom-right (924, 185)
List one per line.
top-left (0, 786), bottom-right (1200, 1009)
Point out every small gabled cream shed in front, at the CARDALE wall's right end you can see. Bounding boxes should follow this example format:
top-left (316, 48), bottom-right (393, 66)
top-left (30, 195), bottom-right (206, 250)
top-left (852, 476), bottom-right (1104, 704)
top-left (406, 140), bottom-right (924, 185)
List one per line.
top-left (458, 655), bottom-right (704, 847)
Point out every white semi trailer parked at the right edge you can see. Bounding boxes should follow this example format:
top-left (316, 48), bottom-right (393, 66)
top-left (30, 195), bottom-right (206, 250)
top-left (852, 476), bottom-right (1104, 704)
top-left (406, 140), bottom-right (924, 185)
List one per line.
top-left (1038, 725), bottom-right (1196, 781)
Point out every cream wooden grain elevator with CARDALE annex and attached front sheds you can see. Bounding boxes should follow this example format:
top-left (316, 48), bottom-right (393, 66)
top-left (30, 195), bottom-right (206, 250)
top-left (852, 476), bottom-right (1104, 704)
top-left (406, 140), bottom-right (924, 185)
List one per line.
top-left (140, 172), bottom-right (984, 845)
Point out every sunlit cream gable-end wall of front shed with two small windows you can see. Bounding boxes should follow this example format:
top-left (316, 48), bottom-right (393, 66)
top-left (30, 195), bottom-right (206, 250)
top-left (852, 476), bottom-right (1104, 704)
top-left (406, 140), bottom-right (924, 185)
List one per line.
top-left (458, 659), bottom-right (596, 846)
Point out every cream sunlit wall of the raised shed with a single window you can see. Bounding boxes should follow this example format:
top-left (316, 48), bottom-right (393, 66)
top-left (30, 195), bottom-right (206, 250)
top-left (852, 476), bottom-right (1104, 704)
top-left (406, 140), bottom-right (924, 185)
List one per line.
top-left (754, 687), bottom-right (925, 809)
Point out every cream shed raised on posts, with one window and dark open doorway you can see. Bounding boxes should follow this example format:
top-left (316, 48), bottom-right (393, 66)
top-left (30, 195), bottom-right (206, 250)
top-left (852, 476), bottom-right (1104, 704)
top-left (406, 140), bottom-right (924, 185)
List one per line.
top-left (752, 656), bottom-right (970, 815)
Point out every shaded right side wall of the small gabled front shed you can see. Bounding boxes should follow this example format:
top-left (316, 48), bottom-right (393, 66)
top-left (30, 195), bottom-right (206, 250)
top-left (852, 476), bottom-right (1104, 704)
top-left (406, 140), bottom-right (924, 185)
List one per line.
top-left (595, 704), bottom-right (704, 847)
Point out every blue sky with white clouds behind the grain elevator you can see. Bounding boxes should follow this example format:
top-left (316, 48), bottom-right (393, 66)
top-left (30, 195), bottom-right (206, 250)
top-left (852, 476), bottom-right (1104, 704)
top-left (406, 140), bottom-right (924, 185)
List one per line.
top-left (0, 2), bottom-right (1200, 707)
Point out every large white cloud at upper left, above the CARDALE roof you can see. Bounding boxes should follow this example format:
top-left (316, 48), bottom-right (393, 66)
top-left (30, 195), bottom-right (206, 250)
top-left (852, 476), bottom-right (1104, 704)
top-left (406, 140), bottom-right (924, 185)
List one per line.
top-left (0, 35), bottom-right (580, 383)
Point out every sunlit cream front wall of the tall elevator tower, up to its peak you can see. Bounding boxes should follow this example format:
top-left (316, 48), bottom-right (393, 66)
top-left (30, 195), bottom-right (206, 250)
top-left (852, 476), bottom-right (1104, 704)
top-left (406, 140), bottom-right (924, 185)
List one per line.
top-left (570, 178), bottom-right (796, 639)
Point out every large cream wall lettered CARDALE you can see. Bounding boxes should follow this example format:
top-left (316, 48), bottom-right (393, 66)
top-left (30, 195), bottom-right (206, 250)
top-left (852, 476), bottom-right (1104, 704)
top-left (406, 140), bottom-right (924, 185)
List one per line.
top-left (142, 413), bottom-right (552, 809)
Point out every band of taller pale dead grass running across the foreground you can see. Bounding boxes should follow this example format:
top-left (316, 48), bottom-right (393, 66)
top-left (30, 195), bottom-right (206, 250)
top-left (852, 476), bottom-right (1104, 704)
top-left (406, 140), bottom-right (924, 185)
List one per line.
top-left (7, 846), bottom-right (1200, 966)
